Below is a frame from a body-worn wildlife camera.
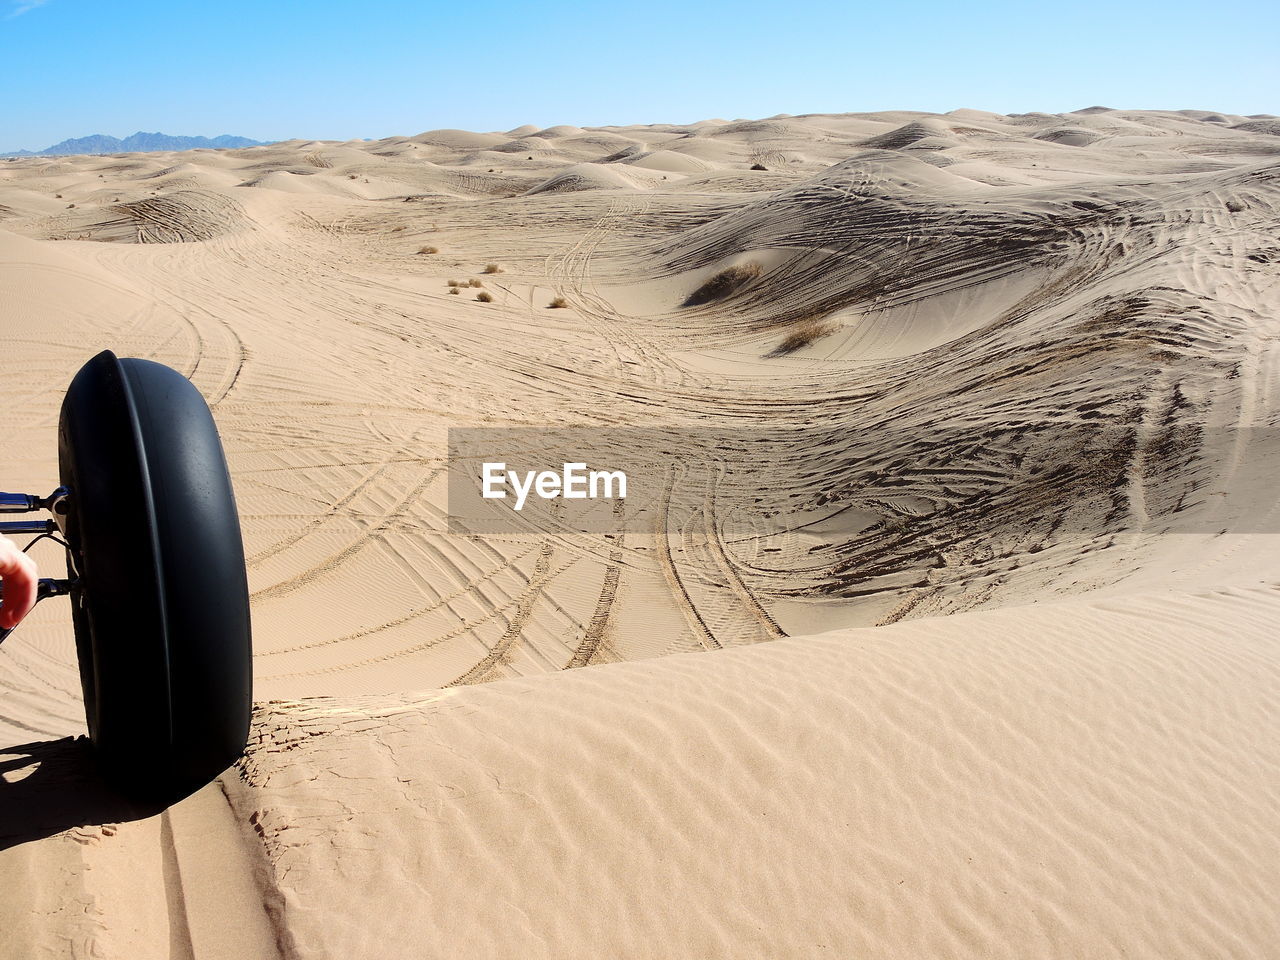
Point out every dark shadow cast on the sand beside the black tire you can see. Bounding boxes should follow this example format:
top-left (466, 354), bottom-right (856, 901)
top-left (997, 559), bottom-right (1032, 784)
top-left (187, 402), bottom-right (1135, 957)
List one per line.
top-left (0, 737), bottom-right (164, 850)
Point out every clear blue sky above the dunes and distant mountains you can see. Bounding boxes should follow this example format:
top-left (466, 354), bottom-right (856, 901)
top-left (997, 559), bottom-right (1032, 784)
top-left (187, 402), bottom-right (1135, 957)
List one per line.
top-left (0, 0), bottom-right (1280, 150)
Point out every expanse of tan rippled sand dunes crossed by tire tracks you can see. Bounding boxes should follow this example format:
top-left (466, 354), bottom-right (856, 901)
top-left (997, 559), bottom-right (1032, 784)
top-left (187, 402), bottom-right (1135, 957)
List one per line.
top-left (0, 108), bottom-right (1280, 957)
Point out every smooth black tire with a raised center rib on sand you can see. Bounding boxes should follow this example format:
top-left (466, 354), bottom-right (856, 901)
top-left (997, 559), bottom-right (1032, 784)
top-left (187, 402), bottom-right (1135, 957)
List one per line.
top-left (58, 351), bottom-right (252, 803)
